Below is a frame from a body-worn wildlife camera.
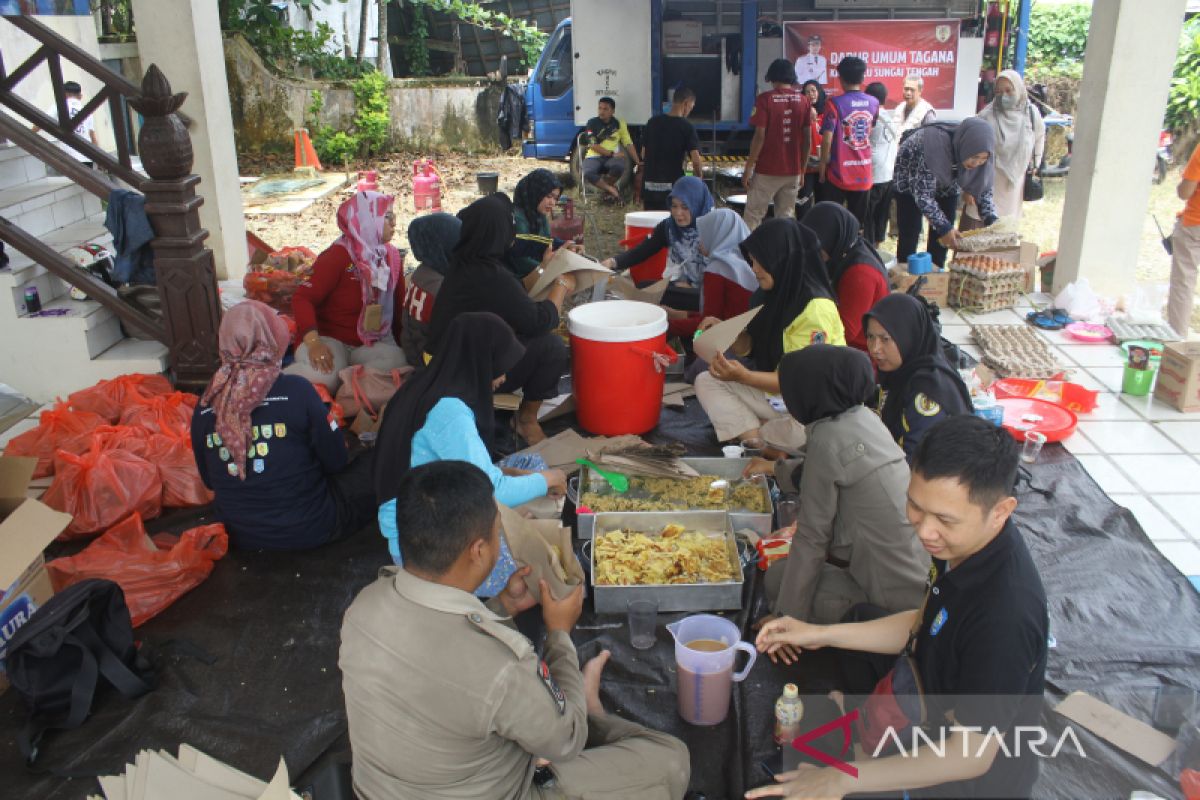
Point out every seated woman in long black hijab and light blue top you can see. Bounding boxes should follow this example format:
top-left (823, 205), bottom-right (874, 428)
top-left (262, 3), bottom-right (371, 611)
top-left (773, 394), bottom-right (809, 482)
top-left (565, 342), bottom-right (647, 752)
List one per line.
top-left (373, 313), bottom-right (566, 596)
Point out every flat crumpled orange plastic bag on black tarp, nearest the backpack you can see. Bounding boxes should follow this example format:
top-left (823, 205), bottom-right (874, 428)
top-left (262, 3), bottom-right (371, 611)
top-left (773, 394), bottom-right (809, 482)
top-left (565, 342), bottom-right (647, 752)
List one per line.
top-left (46, 513), bottom-right (229, 627)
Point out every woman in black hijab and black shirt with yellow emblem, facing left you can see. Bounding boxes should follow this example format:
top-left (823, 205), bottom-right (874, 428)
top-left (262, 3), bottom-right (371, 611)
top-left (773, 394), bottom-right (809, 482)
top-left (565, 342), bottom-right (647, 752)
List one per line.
top-left (863, 294), bottom-right (972, 462)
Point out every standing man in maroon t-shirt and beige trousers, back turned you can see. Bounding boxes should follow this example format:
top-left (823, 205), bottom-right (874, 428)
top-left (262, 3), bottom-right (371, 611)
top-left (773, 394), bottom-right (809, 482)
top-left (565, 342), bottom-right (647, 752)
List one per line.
top-left (742, 59), bottom-right (812, 230)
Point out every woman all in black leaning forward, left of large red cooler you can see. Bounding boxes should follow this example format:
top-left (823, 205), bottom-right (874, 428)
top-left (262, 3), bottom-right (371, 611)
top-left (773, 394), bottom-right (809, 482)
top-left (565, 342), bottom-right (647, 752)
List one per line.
top-left (426, 194), bottom-right (575, 444)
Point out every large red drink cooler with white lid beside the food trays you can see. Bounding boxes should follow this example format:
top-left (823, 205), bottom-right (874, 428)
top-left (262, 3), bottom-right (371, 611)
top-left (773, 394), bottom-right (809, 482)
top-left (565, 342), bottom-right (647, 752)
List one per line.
top-left (566, 300), bottom-right (678, 437)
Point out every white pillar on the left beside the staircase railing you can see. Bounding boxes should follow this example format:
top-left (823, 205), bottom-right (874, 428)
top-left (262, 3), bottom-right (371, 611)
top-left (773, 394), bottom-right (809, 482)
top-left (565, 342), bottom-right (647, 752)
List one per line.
top-left (133, 0), bottom-right (247, 279)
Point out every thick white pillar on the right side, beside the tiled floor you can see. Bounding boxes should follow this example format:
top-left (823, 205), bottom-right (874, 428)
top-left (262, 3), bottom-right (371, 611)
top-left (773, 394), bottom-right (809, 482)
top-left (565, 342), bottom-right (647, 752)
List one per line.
top-left (1054, 0), bottom-right (1187, 297)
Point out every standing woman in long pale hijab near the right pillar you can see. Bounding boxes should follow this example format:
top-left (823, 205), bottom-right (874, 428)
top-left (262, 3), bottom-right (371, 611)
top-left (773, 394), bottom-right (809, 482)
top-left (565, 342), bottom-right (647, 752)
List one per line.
top-left (966, 70), bottom-right (1046, 221)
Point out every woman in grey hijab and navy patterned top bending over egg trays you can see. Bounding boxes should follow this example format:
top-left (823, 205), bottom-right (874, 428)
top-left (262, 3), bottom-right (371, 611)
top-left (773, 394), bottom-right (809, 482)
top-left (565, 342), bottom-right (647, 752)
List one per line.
top-left (892, 116), bottom-right (996, 266)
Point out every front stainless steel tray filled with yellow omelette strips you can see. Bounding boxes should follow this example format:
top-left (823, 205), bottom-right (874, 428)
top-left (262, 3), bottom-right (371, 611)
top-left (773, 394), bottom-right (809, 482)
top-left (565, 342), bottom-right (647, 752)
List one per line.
top-left (589, 511), bottom-right (743, 614)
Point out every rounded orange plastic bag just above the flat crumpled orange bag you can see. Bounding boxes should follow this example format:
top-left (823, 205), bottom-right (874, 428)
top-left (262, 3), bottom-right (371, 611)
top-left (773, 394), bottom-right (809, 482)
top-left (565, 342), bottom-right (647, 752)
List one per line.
top-left (42, 440), bottom-right (162, 540)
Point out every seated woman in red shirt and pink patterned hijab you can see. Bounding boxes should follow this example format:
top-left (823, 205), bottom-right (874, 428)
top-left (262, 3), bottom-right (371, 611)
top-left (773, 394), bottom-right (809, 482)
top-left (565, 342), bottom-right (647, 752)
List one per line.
top-left (286, 192), bottom-right (407, 392)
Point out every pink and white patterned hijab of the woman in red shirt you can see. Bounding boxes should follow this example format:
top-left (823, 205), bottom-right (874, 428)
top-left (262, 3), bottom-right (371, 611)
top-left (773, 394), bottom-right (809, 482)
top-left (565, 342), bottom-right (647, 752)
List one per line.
top-left (334, 192), bottom-right (403, 345)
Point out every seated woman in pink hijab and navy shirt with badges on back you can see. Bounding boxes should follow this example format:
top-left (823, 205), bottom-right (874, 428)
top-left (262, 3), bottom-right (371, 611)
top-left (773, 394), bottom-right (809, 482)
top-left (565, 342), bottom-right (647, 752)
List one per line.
top-left (192, 300), bottom-right (376, 549)
